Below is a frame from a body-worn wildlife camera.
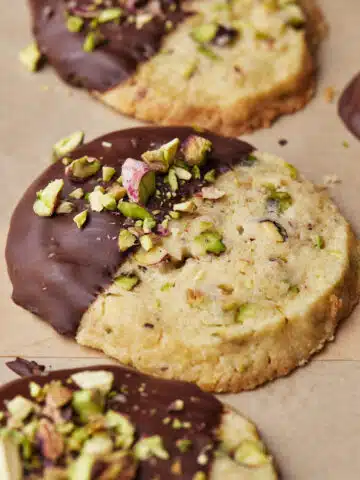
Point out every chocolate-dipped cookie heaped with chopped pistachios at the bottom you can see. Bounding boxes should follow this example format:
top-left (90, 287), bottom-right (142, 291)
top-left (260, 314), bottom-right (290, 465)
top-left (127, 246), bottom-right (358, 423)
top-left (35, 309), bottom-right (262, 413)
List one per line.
top-left (0, 366), bottom-right (278, 480)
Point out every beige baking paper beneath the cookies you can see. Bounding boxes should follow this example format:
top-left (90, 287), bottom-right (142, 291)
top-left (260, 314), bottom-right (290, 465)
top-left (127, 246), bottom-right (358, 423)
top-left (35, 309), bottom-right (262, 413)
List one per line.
top-left (0, 0), bottom-right (360, 480)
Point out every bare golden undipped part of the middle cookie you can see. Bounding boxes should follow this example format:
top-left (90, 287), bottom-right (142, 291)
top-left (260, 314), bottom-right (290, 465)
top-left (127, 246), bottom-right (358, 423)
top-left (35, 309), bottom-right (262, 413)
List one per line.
top-left (77, 153), bottom-right (358, 392)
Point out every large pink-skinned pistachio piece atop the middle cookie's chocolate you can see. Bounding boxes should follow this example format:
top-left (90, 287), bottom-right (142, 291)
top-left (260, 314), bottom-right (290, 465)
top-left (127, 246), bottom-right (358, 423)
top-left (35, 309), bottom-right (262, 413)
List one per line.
top-left (121, 158), bottom-right (155, 205)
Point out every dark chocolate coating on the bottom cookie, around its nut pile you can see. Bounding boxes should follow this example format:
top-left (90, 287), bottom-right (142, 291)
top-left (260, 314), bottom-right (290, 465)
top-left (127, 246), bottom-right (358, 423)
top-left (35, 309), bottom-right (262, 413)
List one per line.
top-left (0, 366), bottom-right (223, 480)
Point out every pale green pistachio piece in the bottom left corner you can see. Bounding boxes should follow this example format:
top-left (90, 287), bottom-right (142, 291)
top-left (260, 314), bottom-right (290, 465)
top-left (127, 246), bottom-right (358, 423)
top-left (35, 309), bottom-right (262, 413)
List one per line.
top-left (0, 435), bottom-right (23, 480)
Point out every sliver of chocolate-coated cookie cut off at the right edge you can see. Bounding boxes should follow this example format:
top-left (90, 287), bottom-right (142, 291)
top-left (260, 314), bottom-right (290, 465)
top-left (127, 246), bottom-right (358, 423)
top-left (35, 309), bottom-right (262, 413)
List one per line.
top-left (338, 73), bottom-right (360, 139)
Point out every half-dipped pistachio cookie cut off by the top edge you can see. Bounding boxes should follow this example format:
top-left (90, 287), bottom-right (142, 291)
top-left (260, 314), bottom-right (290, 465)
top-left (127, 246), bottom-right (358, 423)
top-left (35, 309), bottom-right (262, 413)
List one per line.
top-left (23, 0), bottom-right (325, 135)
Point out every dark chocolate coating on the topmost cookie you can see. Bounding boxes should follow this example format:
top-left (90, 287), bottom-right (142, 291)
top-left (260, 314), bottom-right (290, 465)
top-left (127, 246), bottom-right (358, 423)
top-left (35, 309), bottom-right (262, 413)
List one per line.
top-left (29, 0), bottom-right (186, 92)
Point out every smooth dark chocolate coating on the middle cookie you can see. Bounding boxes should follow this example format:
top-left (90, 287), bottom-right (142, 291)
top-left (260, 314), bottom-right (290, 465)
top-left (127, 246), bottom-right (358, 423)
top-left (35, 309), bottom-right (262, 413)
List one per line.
top-left (6, 127), bottom-right (253, 335)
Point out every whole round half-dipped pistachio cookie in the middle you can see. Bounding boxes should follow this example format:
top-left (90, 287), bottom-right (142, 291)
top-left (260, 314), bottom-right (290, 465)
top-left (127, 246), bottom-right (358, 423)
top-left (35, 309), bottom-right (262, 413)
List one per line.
top-left (6, 127), bottom-right (359, 392)
